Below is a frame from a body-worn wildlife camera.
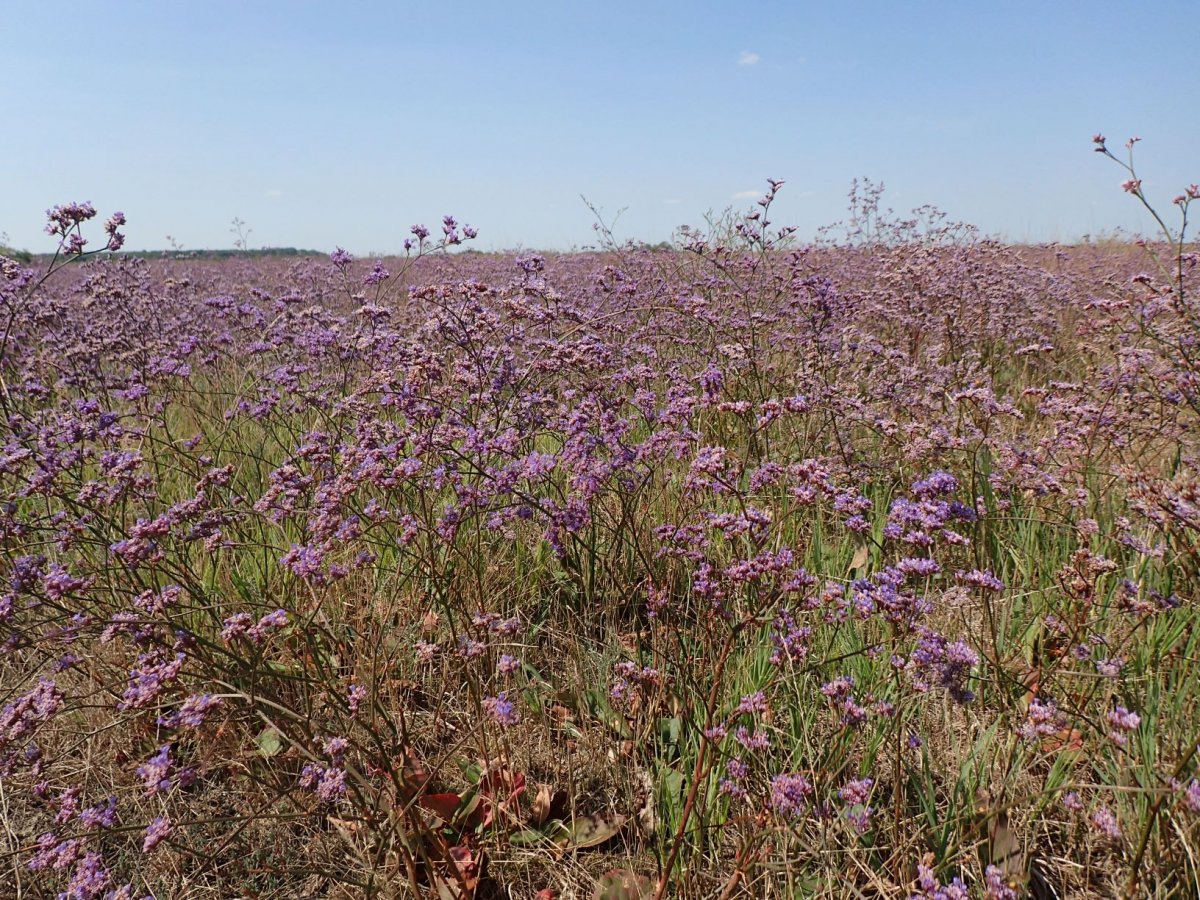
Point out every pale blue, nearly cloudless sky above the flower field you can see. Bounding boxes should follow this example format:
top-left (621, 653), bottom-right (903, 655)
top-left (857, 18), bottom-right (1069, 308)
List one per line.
top-left (0, 0), bottom-right (1200, 253)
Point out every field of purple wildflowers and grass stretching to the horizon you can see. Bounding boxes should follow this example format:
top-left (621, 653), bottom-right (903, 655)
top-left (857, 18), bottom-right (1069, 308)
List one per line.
top-left (0, 158), bottom-right (1200, 900)
